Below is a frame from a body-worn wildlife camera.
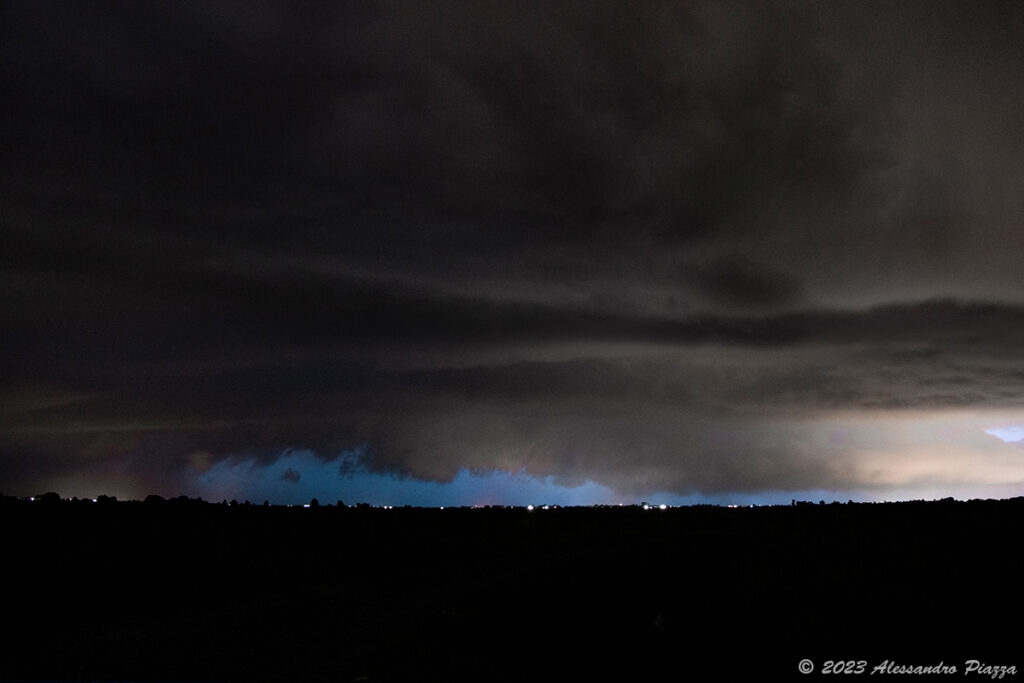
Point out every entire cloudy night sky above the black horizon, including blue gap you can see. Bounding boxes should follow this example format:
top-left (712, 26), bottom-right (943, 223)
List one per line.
top-left (0, 0), bottom-right (1024, 505)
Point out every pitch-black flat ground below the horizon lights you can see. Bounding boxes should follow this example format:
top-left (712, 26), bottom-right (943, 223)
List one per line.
top-left (0, 499), bottom-right (1024, 682)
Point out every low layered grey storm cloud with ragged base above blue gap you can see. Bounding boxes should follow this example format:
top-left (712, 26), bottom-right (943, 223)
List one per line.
top-left (3, 302), bottom-right (1024, 494)
